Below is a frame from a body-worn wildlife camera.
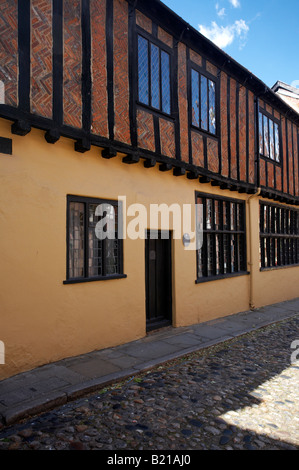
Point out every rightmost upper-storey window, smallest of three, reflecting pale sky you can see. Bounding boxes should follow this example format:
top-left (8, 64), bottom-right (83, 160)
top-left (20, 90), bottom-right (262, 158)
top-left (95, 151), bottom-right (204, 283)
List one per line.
top-left (259, 112), bottom-right (280, 163)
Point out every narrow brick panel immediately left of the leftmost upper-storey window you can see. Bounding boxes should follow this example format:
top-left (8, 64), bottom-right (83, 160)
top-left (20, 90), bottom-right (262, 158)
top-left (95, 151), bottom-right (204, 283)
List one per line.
top-left (114, 0), bottom-right (131, 144)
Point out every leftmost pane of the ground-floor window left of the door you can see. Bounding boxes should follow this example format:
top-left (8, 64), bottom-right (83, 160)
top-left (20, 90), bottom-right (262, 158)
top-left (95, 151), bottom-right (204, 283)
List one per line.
top-left (69, 202), bottom-right (84, 278)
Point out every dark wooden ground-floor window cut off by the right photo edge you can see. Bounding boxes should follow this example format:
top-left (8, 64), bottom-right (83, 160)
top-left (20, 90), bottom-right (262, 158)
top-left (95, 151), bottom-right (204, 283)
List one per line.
top-left (260, 203), bottom-right (299, 268)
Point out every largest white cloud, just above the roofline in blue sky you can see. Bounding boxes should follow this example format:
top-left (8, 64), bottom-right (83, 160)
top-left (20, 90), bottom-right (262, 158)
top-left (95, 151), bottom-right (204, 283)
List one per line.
top-left (199, 20), bottom-right (249, 49)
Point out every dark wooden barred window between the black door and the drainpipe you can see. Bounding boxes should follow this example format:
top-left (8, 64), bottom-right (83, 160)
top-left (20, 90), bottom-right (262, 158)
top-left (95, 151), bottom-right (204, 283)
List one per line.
top-left (196, 193), bottom-right (246, 282)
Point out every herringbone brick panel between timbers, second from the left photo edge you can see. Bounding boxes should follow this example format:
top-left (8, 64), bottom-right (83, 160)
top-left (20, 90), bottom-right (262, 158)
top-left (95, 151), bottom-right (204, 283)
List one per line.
top-left (31, 0), bottom-right (53, 118)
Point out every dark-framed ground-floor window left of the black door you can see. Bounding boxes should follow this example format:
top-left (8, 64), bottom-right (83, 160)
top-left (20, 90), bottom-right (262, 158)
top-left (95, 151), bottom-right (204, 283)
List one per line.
top-left (65, 196), bottom-right (124, 283)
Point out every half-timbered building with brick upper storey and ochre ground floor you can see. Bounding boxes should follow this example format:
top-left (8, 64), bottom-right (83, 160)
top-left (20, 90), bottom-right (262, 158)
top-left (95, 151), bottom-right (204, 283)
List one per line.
top-left (0, 0), bottom-right (299, 377)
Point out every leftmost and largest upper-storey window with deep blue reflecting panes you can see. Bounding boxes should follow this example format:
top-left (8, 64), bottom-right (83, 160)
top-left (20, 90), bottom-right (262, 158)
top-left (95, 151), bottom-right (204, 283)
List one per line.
top-left (138, 35), bottom-right (171, 114)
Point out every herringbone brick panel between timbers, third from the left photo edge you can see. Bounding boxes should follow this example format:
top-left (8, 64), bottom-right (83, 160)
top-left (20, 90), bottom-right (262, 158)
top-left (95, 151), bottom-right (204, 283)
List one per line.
top-left (63, 0), bottom-right (82, 127)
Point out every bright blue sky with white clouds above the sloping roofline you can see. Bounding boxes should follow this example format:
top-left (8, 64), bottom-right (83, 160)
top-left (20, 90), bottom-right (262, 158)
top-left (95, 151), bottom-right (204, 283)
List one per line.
top-left (162, 0), bottom-right (299, 88)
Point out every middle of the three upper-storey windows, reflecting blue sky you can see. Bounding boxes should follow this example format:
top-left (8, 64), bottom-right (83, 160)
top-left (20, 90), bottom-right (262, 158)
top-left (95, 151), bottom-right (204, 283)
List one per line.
top-left (191, 69), bottom-right (216, 135)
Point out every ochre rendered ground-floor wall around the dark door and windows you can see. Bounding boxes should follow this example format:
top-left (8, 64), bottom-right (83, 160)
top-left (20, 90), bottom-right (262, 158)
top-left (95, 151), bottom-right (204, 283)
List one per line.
top-left (0, 120), bottom-right (299, 379)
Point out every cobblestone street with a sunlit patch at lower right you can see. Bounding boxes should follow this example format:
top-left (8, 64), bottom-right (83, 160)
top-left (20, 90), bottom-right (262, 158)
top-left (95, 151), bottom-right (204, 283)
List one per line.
top-left (0, 316), bottom-right (299, 451)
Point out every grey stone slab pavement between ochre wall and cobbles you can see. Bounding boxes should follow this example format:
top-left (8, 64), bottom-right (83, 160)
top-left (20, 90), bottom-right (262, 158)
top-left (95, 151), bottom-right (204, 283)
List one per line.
top-left (0, 298), bottom-right (299, 424)
